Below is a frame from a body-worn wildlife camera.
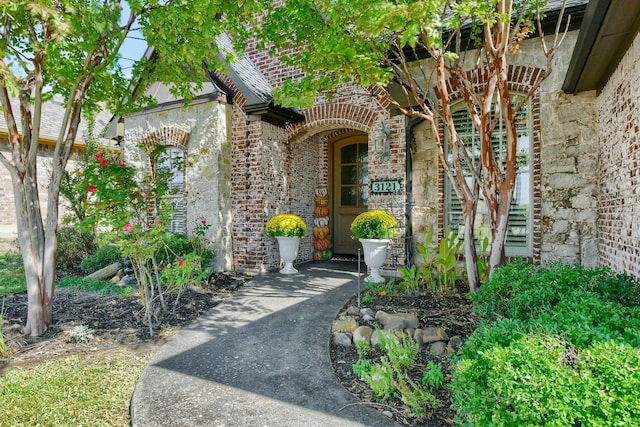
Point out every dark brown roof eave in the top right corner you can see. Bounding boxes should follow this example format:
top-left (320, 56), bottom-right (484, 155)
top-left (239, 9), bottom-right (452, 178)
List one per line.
top-left (562, 0), bottom-right (640, 93)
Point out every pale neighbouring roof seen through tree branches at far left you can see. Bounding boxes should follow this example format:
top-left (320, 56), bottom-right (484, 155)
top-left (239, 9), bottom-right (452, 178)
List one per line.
top-left (0, 95), bottom-right (111, 142)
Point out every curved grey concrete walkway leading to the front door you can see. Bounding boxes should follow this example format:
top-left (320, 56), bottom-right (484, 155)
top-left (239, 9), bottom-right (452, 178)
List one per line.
top-left (131, 261), bottom-right (398, 427)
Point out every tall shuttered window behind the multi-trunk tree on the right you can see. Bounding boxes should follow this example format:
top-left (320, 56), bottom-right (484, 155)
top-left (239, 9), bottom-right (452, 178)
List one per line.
top-left (445, 98), bottom-right (533, 256)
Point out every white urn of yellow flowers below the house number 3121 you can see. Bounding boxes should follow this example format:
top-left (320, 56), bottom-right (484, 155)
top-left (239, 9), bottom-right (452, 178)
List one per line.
top-left (351, 209), bottom-right (398, 283)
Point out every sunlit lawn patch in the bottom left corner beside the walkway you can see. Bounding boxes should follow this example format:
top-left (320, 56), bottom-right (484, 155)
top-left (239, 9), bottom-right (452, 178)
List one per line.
top-left (0, 349), bottom-right (149, 427)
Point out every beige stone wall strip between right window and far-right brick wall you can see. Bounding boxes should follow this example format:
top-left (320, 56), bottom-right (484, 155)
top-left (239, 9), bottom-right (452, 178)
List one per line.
top-left (540, 92), bottom-right (598, 267)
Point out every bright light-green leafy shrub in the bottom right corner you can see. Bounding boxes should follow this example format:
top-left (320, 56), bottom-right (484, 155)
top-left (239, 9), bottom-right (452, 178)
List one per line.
top-left (451, 334), bottom-right (640, 426)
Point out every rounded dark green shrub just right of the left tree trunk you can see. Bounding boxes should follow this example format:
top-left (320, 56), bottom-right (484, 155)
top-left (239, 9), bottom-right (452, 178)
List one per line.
top-left (56, 226), bottom-right (98, 277)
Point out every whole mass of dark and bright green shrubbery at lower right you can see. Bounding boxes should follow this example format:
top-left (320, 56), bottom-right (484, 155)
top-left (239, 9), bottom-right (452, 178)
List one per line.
top-left (451, 262), bottom-right (640, 426)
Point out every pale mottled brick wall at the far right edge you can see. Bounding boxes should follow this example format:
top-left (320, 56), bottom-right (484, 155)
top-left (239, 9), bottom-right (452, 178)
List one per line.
top-left (598, 34), bottom-right (640, 277)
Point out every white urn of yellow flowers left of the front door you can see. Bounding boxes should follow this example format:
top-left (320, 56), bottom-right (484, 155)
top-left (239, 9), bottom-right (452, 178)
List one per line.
top-left (266, 214), bottom-right (307, 274)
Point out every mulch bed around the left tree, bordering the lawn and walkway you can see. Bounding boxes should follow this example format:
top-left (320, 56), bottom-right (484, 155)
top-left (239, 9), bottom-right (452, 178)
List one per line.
top-left (0, 274), bottom-right (247, 370)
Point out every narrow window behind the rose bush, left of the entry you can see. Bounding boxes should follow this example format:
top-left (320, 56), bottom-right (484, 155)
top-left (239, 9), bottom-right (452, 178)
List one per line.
top-left (155, 147), bottom-right (186, 234)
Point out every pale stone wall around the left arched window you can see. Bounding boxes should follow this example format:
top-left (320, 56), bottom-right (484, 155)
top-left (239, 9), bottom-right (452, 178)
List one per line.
top-left (124, 101), bottom-right (233, 271)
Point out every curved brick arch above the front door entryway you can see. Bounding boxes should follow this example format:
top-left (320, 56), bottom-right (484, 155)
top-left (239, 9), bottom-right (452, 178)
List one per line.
top-left (288, 103), bottom-right (379, 141)
